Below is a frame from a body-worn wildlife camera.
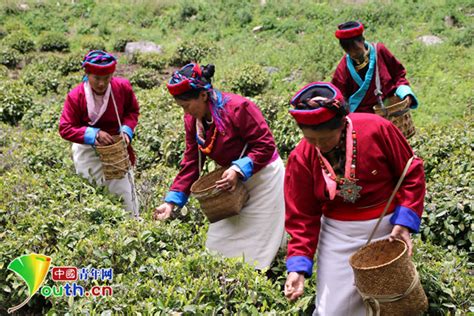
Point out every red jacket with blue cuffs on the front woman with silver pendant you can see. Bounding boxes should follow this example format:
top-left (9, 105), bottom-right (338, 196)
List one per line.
top-left (285, 113), bottom-right (425, 274)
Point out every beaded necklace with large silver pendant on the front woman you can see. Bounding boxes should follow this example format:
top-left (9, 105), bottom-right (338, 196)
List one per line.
top-left (318, 131), bottom-right (362, 203)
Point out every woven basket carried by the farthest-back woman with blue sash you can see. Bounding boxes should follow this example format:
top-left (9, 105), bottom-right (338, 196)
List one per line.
top-left (373, 96), bottom-right (416, 139)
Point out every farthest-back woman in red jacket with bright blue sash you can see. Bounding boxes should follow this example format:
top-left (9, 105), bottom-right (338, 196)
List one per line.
top-left (331, 21), bottom-right (418, 113)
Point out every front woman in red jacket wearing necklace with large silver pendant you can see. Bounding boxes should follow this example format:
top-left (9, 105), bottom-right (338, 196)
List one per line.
top-left (285, 82), bottom-right (425, 315)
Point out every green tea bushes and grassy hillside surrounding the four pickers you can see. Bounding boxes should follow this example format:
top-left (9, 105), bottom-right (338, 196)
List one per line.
top-left (0, 0), bottom-right (474, 315)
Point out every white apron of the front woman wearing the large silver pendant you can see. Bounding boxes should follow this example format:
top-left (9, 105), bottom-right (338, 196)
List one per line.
top-left (313, 214), bottom-right (393, 316)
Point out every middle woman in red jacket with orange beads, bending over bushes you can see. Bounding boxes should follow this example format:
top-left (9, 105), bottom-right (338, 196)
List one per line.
top-left (154, 64), bottom-right (284, 269)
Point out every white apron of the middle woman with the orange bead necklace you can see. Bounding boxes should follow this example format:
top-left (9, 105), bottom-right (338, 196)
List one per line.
top-left (206, 158), bottom-right (286, 269)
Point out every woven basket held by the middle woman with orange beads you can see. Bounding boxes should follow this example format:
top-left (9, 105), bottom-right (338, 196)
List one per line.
top-left (191, 168), bottom-right (249, 223)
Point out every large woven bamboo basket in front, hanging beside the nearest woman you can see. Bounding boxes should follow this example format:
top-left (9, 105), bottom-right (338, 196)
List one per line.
top-left (349, 239), bottom-right (428, 315)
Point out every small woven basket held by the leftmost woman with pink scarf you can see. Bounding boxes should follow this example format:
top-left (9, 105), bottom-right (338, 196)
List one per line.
top-left (95, 135), bottom-right (130, 180)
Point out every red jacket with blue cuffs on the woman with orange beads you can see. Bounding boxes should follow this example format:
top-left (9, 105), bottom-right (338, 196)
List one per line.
top-left (165, 93), bottom-right (278, 206)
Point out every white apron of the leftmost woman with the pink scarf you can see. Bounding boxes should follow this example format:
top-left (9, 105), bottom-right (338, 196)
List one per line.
top-left (72, 143), bottom-right (139, 217)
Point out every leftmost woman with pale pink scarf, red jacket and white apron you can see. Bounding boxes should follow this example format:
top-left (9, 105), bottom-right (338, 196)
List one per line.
top-left (59, 50), bottom-right (139, 216)
